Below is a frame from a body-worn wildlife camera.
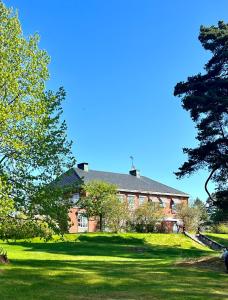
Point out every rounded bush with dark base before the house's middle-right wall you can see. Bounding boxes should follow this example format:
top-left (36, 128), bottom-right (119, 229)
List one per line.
top-left (132, 202), bottom-right (164, 232)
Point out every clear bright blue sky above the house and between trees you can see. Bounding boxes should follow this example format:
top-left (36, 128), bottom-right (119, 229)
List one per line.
top-left (4, 0), bottom-right (228, 200)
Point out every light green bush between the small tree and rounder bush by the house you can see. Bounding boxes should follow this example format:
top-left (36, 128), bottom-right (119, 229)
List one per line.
top-left (104, 196), bottom-right (131, 232)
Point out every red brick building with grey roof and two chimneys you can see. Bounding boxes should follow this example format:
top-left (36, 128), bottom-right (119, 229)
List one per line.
top-left (59, 163), bottom-right (189, 233)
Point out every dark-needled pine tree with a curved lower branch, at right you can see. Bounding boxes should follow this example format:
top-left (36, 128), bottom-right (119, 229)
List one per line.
top-left (174, 21), bottom-right (228, 217)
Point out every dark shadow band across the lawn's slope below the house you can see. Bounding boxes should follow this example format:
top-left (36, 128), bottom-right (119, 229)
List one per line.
top-left (8, 235), bottom-right (208, 259)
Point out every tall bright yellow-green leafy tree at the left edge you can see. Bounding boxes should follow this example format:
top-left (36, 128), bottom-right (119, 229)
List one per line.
top-left (0, 1), bottom-right (74, 237)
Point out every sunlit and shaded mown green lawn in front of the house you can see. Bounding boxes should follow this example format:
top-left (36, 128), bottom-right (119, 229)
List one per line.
top-left (0, 234), bottom-right (228, 300)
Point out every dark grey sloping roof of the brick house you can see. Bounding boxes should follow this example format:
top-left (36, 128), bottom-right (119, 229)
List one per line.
top-left (60, 168), bottom-right (188, 197)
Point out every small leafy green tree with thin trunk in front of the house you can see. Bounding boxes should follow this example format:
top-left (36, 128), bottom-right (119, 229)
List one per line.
top-left (79, 180), bottom-right (117, 231)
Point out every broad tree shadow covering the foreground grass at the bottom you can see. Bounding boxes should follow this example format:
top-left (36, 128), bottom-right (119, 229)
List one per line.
top-left (0, 259), bottom-right (228, 300)
